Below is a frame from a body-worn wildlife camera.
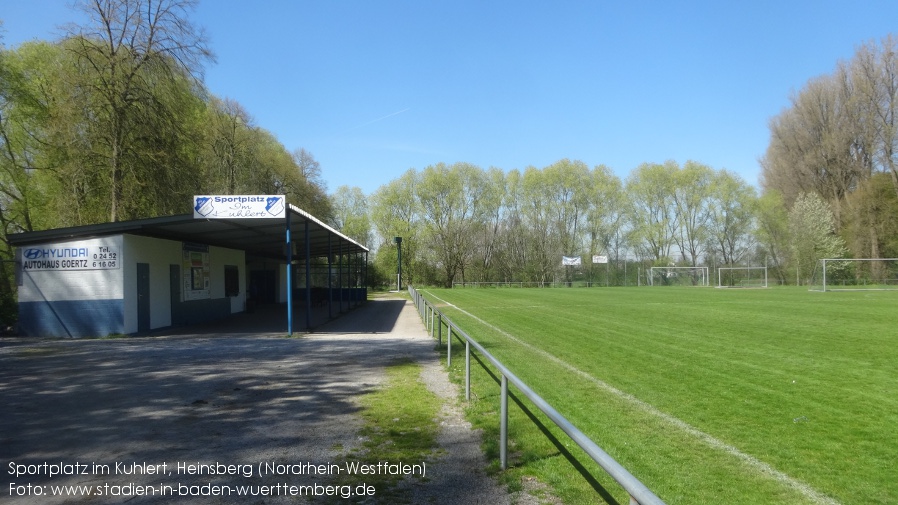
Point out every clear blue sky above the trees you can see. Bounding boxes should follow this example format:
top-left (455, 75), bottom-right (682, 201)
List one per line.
top-left (0, 0), bottom-right (898, 194)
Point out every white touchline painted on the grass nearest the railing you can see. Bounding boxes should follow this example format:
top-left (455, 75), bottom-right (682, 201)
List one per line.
top-left (425, 291), bottom-right (841, 505)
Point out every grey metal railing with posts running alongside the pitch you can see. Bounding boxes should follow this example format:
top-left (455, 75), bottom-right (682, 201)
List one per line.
top-left (408, 286), bottom-right (665, 505)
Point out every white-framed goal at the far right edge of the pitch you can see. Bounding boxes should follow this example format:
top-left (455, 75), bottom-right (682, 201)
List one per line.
top-left (809, 258), bottom-right (898, 291)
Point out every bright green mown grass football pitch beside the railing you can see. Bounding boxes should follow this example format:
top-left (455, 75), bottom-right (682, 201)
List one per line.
top-left (422, 287), bottom-right (898, 504)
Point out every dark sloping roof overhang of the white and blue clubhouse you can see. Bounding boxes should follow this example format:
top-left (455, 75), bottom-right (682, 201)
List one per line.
top-left (7, 205), bottom-right (368, 261)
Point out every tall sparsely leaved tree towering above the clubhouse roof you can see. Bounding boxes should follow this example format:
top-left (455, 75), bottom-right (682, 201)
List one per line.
top-left (68, 0), bottom-right (212, 221)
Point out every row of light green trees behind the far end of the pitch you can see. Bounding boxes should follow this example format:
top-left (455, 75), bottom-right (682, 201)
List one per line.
top-left (356, 159), bottom-right (812, 286)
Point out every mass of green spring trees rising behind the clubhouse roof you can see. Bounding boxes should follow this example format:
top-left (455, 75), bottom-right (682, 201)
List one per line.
top-left (0, 0), bottom-right (332, 228)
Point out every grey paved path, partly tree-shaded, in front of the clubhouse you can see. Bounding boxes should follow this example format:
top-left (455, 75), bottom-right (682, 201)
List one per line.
top-left (0, 298), bottom-right (529, 504)
